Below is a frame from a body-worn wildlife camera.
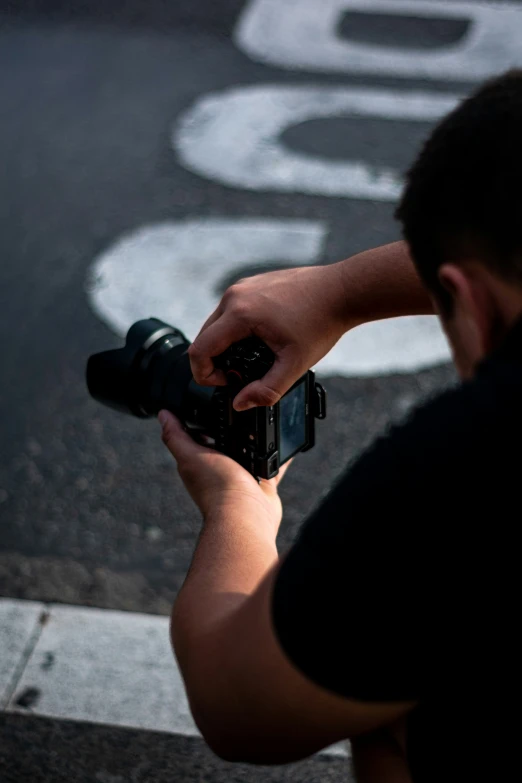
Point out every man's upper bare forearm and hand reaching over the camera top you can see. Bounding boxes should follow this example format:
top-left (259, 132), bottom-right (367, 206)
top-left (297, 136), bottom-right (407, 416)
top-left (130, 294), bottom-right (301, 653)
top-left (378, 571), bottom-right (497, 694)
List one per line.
top-left (189, 242), bottom-right (433, 410)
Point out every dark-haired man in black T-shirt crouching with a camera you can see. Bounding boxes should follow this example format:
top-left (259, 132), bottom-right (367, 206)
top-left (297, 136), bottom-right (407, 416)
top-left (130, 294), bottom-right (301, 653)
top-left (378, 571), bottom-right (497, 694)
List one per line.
top-left (160, 71), bottom-right (522, 783)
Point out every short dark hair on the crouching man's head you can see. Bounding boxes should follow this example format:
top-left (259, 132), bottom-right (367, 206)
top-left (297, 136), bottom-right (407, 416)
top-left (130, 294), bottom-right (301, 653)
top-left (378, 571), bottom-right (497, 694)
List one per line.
top-left (396, 70), bottom-right (522, 313)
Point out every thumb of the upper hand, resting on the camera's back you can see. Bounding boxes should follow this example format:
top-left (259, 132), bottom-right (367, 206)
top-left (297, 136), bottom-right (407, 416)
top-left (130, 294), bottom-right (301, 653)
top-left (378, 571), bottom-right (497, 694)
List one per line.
top-left (233, 346), bottom-right (300, 411)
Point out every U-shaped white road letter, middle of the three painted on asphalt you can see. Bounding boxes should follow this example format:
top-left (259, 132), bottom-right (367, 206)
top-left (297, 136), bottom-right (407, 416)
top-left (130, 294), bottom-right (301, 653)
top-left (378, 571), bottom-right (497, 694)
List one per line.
top-left (172, 85), bottom-right (460, 201)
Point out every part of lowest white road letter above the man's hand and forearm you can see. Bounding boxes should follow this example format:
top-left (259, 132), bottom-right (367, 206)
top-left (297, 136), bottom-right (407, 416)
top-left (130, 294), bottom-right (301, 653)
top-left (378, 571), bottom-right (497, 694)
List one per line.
top-left (89, 218), bottom-right (327, 340)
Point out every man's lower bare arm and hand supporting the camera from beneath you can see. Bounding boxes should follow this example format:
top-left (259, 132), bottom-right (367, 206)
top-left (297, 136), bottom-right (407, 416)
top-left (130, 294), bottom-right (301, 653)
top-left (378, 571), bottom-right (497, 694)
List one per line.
top-left (163, 417), bottom-right (413, 764)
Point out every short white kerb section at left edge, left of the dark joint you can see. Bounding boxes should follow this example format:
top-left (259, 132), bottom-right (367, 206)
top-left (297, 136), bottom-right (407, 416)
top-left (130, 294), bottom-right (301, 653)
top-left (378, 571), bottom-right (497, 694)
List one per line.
top-left (0, 598), bottom-right (45, 709)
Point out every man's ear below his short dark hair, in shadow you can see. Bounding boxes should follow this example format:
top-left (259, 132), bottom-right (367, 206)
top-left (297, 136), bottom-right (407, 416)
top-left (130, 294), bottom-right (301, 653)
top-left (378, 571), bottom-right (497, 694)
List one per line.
top-left (439, 263), bottom-right (497, 361)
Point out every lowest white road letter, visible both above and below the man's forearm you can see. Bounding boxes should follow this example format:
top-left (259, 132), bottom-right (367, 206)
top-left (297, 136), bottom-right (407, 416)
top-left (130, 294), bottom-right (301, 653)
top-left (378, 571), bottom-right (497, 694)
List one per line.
top-left (89, 218), bottom-right (450, 376)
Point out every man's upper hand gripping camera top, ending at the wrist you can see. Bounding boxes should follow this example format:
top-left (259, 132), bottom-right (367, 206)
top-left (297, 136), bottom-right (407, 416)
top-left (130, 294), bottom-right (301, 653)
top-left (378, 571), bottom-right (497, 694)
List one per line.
top-left (189, 264), bottom-right (349, 410)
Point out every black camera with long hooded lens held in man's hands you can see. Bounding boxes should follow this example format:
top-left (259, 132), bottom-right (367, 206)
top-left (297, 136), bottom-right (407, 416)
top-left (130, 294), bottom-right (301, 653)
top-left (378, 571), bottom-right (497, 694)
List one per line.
top-left (87, 318), bottom-right (326, 479)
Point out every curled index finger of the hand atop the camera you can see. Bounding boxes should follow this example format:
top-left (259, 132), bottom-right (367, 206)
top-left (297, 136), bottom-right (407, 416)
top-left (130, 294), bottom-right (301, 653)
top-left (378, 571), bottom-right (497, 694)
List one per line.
top-left (188, 315), bottom-right (251, 386)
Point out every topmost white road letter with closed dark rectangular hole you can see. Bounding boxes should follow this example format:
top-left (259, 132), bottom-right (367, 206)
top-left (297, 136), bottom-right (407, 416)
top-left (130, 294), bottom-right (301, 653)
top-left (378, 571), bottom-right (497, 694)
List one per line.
top-left (234, 0), bottom-right (522, 81)
